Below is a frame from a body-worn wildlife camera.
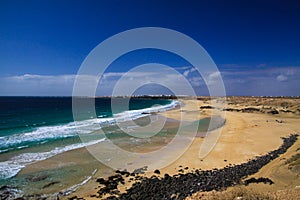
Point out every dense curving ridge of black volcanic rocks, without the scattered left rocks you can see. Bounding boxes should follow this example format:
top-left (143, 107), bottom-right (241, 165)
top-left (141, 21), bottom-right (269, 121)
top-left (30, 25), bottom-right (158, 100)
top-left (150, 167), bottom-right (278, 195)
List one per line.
top-left (102, 134), bottom-right (298, 200)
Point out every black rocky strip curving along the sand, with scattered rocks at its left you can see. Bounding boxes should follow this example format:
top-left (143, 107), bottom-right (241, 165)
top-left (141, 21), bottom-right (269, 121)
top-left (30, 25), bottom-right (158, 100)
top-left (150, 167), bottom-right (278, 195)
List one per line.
top-left (71, 134), bottom-right (298, 200)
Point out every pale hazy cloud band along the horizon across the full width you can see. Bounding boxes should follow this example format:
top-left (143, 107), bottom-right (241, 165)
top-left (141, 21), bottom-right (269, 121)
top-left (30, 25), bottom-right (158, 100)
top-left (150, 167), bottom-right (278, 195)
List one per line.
top-left (0, 67), bottom-right (300, 96)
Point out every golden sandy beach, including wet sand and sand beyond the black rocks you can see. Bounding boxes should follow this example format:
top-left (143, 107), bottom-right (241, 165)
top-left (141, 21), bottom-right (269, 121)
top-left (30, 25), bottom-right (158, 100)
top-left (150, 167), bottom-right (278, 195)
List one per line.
top-left (14, 97), bottom-right (300, 199)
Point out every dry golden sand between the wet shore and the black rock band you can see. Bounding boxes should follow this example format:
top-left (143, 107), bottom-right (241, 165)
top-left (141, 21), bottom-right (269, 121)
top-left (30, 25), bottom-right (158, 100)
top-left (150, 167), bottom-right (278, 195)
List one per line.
top-left (71, 98), bottom-right (300, 199)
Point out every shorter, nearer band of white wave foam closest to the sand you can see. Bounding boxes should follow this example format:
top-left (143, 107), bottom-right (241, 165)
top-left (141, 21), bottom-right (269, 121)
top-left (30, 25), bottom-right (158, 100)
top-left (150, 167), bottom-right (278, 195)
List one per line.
top-left (0, 138), bottom-right (105, 179)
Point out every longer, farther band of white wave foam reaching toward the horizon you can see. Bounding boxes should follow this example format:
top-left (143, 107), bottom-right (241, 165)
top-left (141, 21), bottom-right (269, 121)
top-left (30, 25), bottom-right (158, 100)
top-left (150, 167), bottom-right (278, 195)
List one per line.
top-left (0, 101), bottom-right (179, 153)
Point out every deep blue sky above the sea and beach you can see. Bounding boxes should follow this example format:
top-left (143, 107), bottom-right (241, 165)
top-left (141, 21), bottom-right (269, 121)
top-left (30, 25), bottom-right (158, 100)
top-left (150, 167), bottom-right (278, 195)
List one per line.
top-left (0, 0), bottom-right (300, 95)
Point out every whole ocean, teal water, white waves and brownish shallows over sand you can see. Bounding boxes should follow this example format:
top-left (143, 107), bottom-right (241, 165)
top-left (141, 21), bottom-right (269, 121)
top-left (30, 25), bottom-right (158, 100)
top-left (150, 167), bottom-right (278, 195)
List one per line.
top-left (0, 97), bottom-right (224, 199)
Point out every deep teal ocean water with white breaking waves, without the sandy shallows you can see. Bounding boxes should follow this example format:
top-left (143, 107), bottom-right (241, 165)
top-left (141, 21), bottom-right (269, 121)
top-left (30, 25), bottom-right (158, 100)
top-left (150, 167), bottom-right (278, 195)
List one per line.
top-left (0, 97), bottom-right (178, 185)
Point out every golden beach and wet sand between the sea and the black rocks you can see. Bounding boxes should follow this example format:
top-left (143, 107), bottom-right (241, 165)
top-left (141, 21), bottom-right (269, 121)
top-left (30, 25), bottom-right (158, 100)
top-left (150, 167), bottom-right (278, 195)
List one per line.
top-left (2, 97), bottom-right (300, 199)
